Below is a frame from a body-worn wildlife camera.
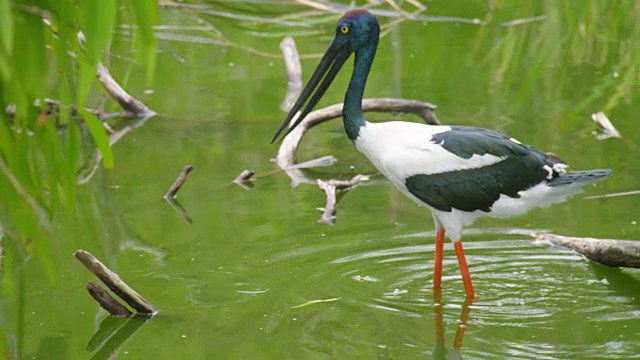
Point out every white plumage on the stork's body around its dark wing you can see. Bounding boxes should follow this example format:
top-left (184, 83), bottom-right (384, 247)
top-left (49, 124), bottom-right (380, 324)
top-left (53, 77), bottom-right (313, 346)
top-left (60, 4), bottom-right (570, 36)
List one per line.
top-left (355, 121), bottom-right (596, 241)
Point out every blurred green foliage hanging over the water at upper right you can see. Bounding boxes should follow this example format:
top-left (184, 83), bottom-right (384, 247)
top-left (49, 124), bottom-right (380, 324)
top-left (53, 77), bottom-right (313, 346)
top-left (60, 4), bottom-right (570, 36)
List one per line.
top-left (474, 0), bottom-right (640, 112)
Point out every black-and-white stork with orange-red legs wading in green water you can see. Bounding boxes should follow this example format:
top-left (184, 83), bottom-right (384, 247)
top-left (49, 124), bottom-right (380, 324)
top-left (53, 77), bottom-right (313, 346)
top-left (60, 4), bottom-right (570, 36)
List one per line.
top-left (271, 10), bottom-right (612, 299)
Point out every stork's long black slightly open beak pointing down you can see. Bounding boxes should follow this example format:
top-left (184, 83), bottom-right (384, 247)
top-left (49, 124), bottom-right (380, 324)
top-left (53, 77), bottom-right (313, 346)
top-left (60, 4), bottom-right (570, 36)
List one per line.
top-left (271, 40), bottom-right (351, 144)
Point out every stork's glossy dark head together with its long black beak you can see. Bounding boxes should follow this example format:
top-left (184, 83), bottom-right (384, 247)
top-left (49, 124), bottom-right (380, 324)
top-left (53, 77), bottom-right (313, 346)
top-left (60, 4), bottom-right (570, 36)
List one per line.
top-left (271, 10), bottom-right (380, 143)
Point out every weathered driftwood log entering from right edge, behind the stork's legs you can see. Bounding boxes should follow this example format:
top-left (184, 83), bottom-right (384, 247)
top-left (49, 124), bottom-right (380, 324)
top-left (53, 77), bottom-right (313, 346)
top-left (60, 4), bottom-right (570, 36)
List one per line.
top-left (536, 234), bottom-right (640, 268)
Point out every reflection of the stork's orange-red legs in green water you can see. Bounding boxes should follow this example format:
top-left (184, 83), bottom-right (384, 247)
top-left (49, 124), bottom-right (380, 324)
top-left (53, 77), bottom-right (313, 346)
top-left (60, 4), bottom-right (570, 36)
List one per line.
top-left (433, 290), bottom-right (473, 359)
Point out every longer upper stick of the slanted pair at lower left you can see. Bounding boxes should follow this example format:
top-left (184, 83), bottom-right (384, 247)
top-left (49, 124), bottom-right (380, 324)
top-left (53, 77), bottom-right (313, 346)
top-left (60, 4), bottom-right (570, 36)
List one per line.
top-left (73, 250), bottom-right (158, 316)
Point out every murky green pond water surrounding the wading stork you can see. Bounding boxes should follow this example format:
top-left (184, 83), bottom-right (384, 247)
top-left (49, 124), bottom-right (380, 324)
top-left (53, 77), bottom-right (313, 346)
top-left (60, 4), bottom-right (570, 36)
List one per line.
top-left (0, 1), bottom-right (640, 359)
